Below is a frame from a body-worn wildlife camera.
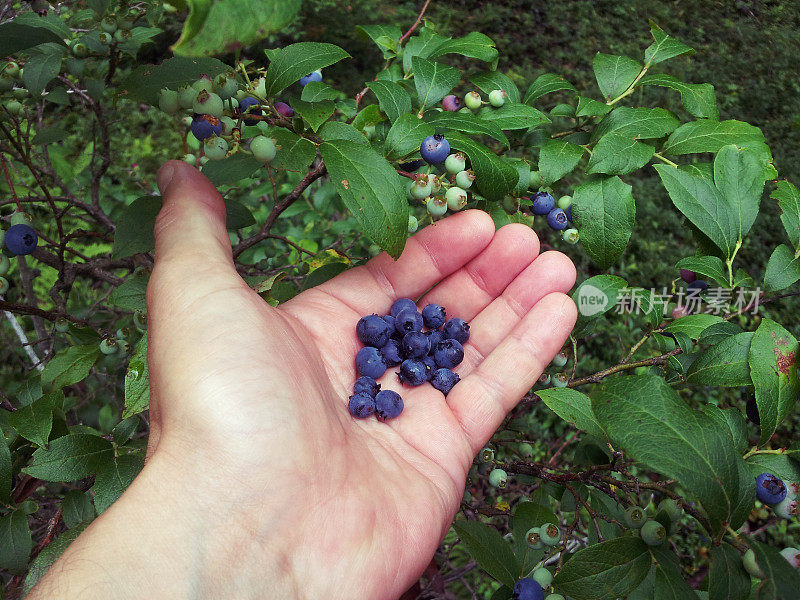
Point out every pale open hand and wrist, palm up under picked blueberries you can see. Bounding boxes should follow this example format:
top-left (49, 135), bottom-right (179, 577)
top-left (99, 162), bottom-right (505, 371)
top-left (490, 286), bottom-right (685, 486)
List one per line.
top-left (29, 161), bottom-right (576, 600)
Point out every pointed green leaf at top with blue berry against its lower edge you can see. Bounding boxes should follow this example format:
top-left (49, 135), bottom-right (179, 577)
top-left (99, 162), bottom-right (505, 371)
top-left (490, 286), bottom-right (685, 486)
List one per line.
top-left (266, 42), bottom-right (350, 96)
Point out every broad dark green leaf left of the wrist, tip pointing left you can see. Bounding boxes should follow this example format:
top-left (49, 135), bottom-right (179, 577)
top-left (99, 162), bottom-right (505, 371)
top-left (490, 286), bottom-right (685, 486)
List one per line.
top-left (23, 433), bottom-right (114, 481)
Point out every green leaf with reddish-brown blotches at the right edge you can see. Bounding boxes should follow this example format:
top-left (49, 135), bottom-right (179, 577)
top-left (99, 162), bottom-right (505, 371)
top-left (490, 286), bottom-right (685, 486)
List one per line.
top-left (749, 318), bottom-right (800, 445)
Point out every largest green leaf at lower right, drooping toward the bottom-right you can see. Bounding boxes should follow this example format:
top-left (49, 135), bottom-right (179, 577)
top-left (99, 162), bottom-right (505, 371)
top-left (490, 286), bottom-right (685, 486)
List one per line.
top-left (592, 375), bottom-right (739, 529)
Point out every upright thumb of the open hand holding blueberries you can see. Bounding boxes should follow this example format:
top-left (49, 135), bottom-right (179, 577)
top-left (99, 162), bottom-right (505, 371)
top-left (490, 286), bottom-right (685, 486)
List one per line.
top-left (154, 160), bottom-right (233, 274)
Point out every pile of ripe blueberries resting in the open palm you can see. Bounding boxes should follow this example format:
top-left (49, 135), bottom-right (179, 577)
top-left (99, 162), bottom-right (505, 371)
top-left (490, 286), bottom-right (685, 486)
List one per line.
top-left (349, 298), bottom-right (469, 420)
